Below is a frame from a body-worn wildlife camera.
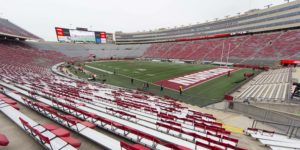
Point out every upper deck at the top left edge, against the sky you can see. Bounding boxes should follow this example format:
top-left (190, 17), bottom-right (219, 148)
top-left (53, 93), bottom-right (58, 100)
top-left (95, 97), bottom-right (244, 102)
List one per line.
top-left (0, 18), bottom-right (41, 40)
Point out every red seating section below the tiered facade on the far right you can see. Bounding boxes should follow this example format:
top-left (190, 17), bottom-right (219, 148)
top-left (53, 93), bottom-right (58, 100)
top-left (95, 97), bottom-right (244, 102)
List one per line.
top-left (143, 30), bottom-right (300, 62)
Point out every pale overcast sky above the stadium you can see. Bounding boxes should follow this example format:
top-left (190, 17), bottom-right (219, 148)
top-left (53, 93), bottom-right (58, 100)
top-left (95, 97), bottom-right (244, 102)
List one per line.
top-left (0, 0), bottom-right (284, 41)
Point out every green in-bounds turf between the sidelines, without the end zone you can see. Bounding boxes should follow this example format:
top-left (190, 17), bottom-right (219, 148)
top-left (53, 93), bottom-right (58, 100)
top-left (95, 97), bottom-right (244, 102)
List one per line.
top-left (87, 60), bottom-right (214, 82)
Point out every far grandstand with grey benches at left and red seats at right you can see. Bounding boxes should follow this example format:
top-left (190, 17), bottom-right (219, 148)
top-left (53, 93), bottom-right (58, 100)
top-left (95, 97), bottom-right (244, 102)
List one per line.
top-left (28, 29), bottom-right (300, 65)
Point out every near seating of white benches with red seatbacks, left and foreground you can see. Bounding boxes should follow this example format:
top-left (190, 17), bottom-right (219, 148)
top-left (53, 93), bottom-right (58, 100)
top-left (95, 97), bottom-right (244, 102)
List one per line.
top-left (0, 41), bottom-right (250, 150)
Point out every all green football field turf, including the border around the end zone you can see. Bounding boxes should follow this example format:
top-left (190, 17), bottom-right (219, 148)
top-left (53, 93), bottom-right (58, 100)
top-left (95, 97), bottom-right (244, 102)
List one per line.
top-left (75, 60), bottom-right (252, 106)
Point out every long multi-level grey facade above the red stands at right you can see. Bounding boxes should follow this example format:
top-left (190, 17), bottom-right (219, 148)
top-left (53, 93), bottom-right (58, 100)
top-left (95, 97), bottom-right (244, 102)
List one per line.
top-left (115, 1), bottom-right (300, 44)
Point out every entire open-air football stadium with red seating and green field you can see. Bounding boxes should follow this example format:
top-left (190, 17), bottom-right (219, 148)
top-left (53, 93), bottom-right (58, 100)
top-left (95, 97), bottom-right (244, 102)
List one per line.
top-left (0, 0), bottom-right (300, 150)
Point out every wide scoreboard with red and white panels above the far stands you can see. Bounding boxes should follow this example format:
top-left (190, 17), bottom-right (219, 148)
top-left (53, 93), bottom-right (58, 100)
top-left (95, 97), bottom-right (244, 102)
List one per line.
top-left (55, 27), bottom-right (113, 44)
